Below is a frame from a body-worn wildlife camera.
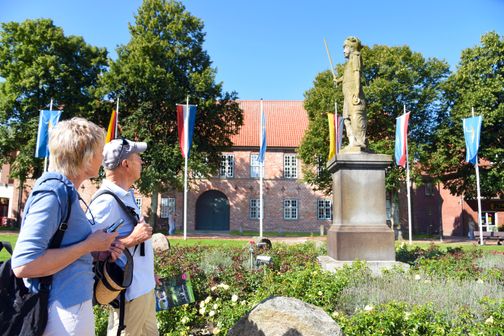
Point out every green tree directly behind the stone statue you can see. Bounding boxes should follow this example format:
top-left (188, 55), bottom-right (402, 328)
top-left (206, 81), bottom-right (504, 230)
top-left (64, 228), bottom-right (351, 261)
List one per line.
top-left (299, 45), bottom-right (449, 192)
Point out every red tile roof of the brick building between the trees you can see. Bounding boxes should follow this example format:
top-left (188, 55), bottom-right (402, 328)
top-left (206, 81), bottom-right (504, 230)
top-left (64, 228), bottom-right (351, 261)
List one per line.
top-left (231, 100), bottom-right (308, 148)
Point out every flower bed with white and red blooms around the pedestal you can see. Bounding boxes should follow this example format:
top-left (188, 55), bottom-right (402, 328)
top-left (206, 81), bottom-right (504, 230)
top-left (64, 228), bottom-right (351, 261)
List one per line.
top-left (96, 243), bottom-right (504, 336)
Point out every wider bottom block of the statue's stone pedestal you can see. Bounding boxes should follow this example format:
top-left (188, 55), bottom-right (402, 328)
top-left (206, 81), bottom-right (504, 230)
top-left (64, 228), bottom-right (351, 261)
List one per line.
top-left (327, 224), bottom-right (395, 261)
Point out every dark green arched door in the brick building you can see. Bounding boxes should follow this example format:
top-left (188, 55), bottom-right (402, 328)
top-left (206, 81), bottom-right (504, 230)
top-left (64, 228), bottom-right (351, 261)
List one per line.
top-left (196, 190), bottom-right (229, 231)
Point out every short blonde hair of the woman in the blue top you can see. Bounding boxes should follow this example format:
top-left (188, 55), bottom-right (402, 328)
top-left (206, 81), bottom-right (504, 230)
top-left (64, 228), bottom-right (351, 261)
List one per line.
top-left (49, 118), bottom-right (105, 177)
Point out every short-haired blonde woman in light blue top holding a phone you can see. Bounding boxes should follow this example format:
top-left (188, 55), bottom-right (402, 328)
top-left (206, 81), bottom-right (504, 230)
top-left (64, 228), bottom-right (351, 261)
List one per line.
top-left (12, 118), bottom-right (122, 336)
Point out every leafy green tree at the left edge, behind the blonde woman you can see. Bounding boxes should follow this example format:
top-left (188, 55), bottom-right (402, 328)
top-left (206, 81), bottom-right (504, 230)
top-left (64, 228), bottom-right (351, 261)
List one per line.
top-left (0, 19), bottom-right (107, 181)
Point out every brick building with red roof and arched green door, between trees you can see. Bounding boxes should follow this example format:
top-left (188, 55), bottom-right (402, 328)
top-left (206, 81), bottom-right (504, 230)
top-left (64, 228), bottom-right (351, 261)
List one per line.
top-left (156, 100), bottom-right (332, 232)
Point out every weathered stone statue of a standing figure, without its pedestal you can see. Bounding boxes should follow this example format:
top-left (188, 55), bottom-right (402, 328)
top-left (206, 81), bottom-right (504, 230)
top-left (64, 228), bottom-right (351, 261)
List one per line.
top-left (334, 36), bottom-right (367, 153)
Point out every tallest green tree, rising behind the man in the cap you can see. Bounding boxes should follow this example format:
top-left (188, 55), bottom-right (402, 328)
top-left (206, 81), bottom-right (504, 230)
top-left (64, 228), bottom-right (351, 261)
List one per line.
top-left (102, 0), bottom-right (243, 224)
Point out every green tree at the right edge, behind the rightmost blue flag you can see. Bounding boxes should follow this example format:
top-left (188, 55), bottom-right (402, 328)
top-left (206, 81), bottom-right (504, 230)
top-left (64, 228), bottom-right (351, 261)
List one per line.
top-left (429, 32), bottom-right (504, 197)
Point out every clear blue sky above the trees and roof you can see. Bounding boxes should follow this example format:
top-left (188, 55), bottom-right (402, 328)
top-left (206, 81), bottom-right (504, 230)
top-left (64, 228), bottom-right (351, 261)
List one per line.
top-left (0, 0), bottom-right (504, 100)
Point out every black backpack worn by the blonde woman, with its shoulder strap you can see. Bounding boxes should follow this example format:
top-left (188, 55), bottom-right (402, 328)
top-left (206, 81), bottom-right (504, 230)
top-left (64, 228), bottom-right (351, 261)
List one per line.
top-left (0, 177), bottom-right (72, 336)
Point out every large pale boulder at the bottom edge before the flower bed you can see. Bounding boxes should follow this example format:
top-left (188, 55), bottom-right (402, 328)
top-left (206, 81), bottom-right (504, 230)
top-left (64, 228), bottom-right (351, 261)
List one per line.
top-left (228, 296), bottom-right (343, 336)
